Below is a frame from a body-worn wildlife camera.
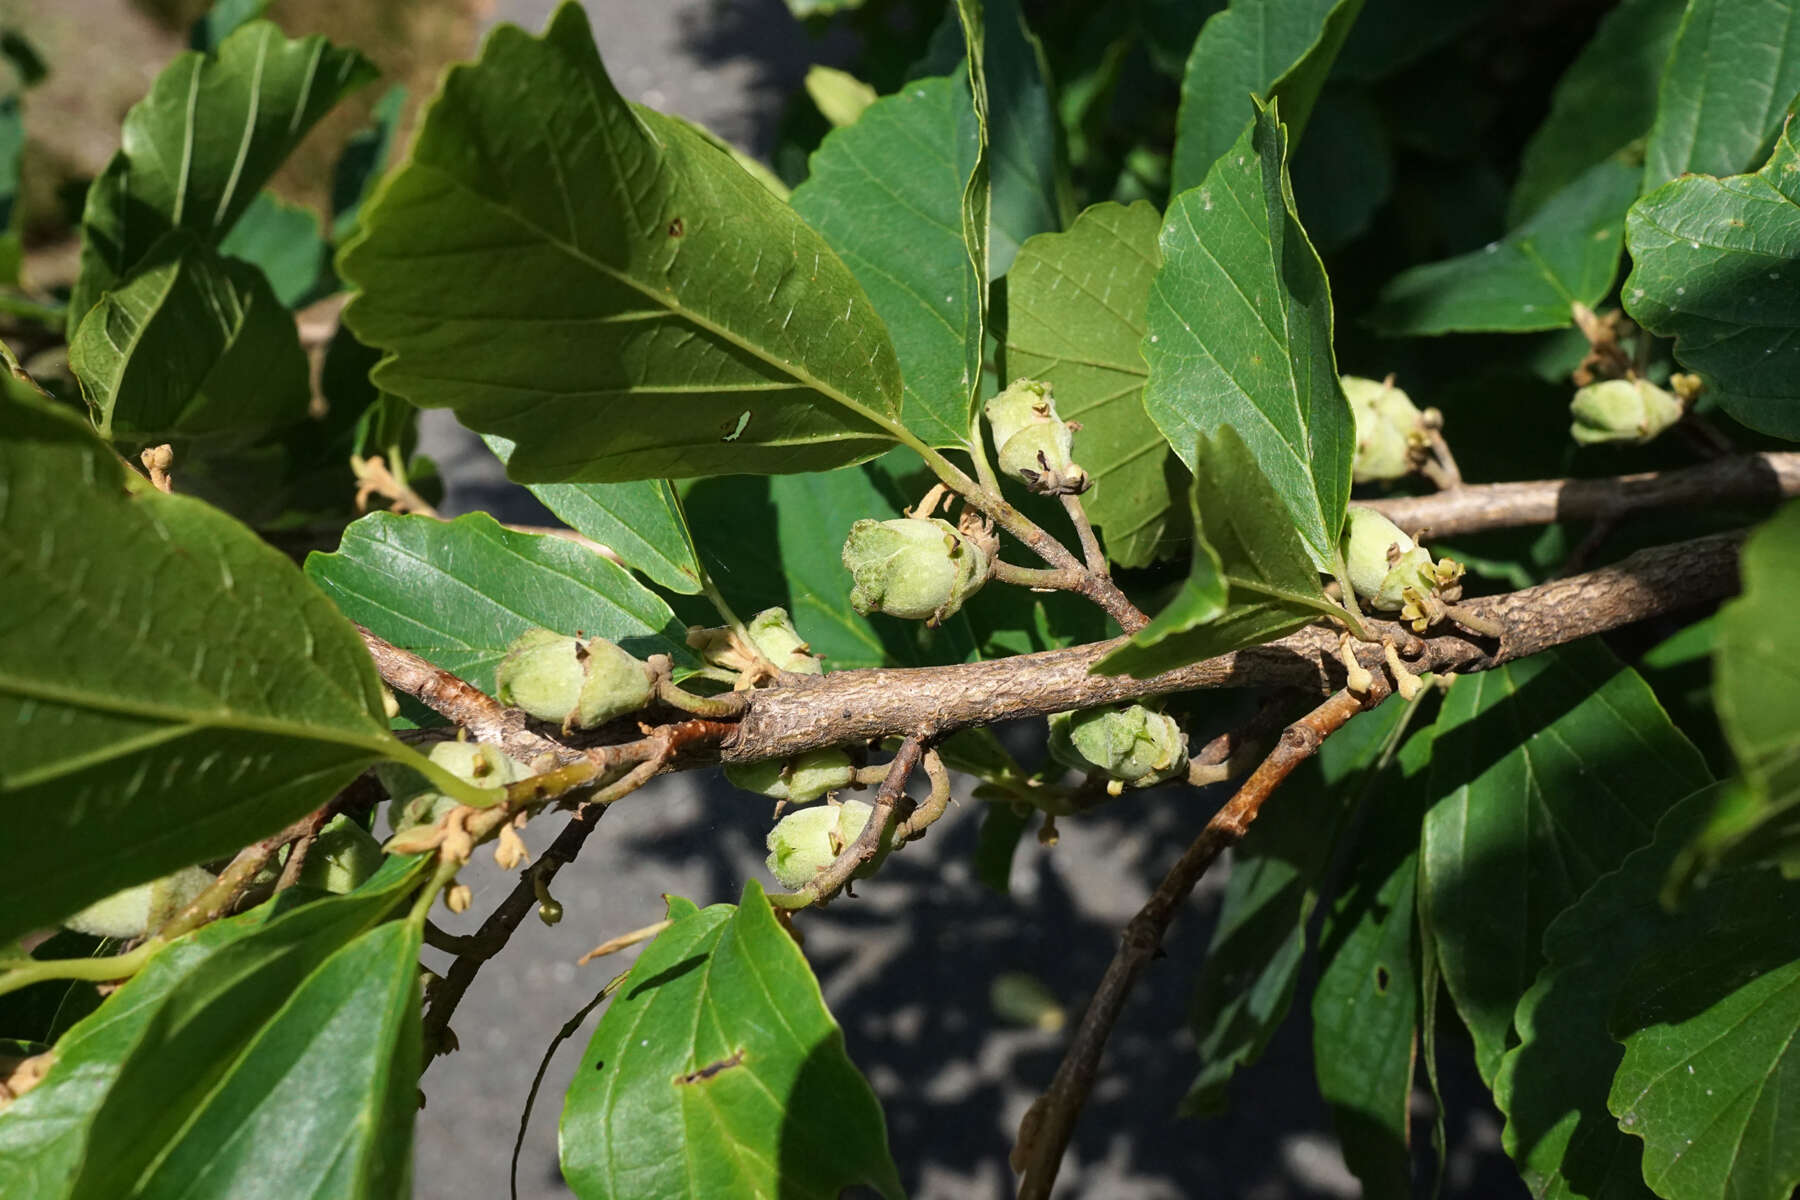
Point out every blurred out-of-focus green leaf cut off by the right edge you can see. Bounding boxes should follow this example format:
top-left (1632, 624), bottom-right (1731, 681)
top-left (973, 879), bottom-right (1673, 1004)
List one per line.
top-left (1687, 504), bottom-right (1800, 874)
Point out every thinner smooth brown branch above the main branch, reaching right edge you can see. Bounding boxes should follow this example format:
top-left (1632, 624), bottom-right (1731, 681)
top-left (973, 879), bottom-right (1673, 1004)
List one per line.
top-left (1357, 453), bottom-right (1800, 538)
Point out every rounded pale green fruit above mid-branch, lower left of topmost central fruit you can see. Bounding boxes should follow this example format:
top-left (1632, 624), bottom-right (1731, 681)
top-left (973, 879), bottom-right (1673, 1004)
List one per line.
top-left (844, 516), bottom-right (988, 624)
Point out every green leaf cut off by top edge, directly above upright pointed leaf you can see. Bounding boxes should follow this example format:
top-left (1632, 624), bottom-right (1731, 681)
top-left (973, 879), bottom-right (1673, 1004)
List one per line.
top-left (1168, 0), bottom-right (1363, 196)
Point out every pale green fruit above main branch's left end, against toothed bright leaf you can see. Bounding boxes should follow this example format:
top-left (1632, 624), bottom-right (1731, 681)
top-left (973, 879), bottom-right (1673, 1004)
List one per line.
top-left (493, 630), bottom-right (652, 729)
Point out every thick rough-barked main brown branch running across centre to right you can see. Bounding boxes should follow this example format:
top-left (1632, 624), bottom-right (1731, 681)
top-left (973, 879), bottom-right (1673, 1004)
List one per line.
top-left (722, 534), bottom-right (1742, 763)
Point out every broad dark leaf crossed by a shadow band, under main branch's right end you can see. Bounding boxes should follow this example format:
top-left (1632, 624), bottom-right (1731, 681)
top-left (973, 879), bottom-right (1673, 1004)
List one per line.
top-left (1420, 640), bottom-right (1710, 1081)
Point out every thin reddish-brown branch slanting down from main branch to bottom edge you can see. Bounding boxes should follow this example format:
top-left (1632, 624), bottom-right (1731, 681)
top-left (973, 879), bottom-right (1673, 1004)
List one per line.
top-left (1013, 690), bottom-right (1360, 1200)
